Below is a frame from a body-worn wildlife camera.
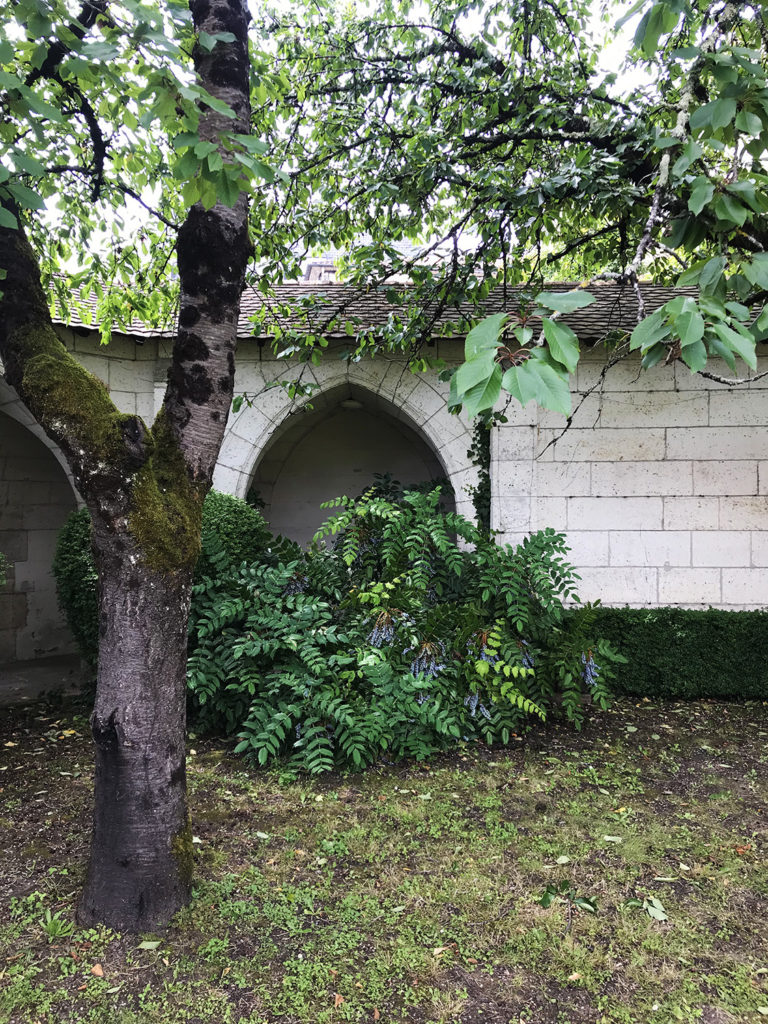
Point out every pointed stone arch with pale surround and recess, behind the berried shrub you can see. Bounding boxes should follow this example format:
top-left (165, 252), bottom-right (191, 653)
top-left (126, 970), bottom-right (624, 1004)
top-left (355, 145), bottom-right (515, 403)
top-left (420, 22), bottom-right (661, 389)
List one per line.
top-left (214, 359), bottom-right (476, 540)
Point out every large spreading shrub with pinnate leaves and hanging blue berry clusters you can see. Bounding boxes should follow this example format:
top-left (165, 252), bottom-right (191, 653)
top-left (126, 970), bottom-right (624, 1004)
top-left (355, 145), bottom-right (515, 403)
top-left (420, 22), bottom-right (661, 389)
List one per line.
top-left (188, 488), bottom-right (618, 772)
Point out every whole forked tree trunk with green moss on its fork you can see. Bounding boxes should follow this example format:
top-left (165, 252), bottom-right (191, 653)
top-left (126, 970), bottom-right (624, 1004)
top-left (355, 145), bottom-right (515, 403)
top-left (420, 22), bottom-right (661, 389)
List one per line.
top-left (0, 0), bottom-right (250, 931)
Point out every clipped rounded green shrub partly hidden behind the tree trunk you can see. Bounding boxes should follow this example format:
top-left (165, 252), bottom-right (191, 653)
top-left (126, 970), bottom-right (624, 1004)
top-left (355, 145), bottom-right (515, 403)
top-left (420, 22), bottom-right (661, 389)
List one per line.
top-left (53, 490), bottom-right (271, 670)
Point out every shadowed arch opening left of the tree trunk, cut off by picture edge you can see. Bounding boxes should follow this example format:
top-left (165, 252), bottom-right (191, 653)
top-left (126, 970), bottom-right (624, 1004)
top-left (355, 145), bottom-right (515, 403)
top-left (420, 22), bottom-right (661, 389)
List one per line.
top-left (0, 412), bottom-right (78, 666)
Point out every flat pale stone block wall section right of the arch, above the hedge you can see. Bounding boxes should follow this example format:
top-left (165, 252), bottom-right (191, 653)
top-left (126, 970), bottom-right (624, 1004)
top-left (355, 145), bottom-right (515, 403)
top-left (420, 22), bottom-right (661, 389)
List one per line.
top-left (492, 354), bottom-right (768, 608)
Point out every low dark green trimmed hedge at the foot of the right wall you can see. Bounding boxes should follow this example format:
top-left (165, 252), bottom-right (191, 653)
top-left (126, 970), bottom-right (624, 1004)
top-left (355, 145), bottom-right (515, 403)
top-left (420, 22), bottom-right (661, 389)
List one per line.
top-left (594, 607), bottom-right (768, 700)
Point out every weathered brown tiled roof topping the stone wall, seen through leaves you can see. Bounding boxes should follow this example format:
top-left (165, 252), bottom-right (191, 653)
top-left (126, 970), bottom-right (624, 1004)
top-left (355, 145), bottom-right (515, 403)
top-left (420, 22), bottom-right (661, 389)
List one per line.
top-left (54, 283), bottom-right (696, 343)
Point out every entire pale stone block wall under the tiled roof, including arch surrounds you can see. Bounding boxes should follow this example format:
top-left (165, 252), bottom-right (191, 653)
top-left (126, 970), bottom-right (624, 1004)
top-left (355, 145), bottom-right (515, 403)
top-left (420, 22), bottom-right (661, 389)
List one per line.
top-left (0, 330), bottom-right (768, 675)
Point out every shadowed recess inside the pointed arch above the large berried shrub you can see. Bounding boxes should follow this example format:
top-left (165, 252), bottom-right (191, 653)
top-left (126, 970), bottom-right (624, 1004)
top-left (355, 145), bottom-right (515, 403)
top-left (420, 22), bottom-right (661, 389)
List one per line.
top-left (249, 396), bottom-right (455, 544)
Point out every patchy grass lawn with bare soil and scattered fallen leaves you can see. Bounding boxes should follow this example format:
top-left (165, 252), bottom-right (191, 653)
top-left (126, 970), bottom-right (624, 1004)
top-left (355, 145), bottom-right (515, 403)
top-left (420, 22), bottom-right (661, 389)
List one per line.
top-left (0, 701), bottom-right (768, 1024)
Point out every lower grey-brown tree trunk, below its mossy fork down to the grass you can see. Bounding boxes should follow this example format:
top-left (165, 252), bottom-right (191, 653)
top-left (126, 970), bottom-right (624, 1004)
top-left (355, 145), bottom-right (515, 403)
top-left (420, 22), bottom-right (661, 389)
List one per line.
top-left (78, 524), bottom-right (191, 932)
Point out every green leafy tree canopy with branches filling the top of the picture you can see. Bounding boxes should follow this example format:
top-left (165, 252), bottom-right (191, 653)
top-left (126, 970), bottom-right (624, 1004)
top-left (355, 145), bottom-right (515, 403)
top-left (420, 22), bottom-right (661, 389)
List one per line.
top-left (0, 0), bottom-right (768, 414)
